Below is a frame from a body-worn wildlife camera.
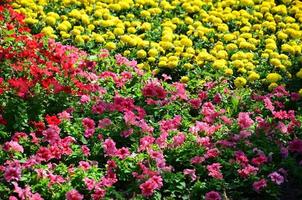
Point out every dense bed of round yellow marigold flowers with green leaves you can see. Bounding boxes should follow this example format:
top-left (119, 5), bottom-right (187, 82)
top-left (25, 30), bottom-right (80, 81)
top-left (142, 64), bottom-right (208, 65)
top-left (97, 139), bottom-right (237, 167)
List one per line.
top-left (13, 0), bottom-right (302, 92)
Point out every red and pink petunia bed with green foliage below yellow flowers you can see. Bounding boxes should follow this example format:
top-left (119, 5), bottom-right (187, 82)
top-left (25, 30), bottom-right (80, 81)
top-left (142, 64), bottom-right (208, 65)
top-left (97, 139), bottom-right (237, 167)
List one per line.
top-left (0, 6), bottom-right (302, 200)
